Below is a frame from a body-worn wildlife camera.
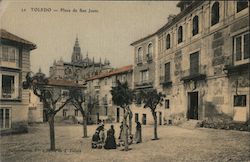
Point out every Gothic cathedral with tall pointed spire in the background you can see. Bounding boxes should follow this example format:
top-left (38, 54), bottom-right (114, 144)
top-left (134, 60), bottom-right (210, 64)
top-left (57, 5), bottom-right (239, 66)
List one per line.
top-left (49, 38), bottom-right (112, 83)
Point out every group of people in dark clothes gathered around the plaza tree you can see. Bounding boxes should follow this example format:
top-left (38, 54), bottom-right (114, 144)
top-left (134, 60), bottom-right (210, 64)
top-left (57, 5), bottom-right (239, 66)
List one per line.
top-left (92, 122), bottom-right (142, 149)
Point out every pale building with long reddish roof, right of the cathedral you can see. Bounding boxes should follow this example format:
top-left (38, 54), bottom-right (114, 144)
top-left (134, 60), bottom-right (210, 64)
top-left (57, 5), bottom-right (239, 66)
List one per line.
top-left (86, 65), bottom-right (133, 123)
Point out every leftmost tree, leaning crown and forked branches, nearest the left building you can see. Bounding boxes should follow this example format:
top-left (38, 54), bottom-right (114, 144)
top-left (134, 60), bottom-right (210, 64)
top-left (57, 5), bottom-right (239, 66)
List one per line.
top-left (23, 71), bottom-right (71, 151)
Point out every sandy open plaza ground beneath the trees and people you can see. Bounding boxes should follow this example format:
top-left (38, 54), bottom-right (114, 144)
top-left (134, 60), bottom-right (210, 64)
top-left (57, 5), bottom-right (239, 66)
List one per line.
top-left (0, 124), bottom-right (250, 162)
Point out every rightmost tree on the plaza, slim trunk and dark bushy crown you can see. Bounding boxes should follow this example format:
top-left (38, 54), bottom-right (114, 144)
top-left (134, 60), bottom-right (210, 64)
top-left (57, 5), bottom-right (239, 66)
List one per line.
top-left (139, 89), bottom-right (165, 140)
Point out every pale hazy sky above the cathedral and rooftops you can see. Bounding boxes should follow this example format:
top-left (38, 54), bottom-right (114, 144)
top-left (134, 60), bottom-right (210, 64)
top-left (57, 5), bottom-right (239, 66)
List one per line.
top-left (0, 0), bottom-right (179, 75)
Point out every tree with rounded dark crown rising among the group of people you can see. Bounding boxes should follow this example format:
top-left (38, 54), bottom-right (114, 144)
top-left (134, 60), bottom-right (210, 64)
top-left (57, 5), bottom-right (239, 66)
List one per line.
top-left (111, 80), bottom-right (134, 151)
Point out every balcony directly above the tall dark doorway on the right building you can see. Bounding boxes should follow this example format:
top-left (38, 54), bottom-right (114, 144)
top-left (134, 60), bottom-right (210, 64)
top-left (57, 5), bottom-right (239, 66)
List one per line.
top-left (181, 66), bottom-right (207, 83)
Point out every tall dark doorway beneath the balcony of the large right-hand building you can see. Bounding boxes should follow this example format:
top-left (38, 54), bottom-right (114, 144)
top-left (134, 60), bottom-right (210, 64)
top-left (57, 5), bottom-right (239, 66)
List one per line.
top-left (187, 92), bottom-right (198, 120)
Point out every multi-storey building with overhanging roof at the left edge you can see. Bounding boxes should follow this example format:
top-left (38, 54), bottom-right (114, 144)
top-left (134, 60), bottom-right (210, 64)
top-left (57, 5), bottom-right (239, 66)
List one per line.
top-left (0, 29), bottom-right (36, 134)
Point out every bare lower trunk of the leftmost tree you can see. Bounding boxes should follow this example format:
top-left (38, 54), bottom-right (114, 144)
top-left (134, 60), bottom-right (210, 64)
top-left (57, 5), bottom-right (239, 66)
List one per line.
top-left (48, 114), bottom-right (56, 151)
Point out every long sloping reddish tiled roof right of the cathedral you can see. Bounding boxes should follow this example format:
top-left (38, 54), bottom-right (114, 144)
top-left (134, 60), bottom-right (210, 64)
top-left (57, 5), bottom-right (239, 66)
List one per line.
top-left (86, 65), bottom-right (133, 81)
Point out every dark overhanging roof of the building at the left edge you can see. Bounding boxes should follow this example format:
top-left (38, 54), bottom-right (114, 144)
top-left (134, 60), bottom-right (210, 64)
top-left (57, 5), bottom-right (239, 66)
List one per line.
top-left (0, 29), bottom-right (36, 50)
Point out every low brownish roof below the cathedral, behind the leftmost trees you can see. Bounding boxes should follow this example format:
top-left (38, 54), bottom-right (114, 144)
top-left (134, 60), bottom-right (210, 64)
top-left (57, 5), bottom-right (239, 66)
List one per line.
top-left (47, 79), bottom-right (84, 88)
